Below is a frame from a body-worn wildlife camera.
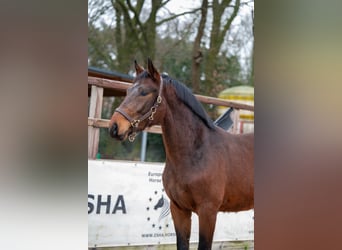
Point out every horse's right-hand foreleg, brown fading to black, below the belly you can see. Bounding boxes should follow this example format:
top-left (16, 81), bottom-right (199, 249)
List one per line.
top-left (198, 206), bottom-right (217, 250)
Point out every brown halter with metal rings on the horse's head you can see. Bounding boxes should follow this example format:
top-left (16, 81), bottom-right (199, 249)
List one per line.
top-left (115, 77), bottom-right (163, 142)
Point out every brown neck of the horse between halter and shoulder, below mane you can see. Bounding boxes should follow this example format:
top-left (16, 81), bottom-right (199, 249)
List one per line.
top-left (161, 90), bottom-right (209, 163)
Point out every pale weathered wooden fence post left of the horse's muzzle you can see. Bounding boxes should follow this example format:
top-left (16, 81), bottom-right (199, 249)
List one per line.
top-left (88, 85), bottom-right (103, 159)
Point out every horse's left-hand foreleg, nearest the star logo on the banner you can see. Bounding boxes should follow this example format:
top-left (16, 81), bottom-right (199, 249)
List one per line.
top-left (170, 201), bottom-right (191, 250)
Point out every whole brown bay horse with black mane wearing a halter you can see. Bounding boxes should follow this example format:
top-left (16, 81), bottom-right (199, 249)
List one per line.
top-left (109, 59), bottom-right (254, 249)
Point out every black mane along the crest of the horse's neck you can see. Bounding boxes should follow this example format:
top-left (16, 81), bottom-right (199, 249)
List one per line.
top-left (162, 74), bottom-right (215, 129)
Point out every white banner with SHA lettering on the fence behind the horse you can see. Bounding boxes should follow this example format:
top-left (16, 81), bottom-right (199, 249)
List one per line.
top-left (88, 160), bottom-right (254, 247)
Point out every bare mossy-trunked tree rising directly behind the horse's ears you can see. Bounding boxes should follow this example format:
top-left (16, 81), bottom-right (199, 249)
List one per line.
top-left (89, 0), bottom-right (200, 72)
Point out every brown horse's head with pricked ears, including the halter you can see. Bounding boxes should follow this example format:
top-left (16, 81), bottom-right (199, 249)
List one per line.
top-left (109, 59), bottom-right (163, 142)
